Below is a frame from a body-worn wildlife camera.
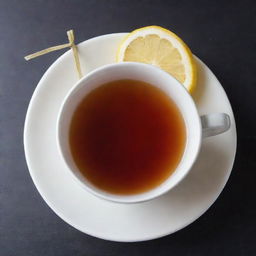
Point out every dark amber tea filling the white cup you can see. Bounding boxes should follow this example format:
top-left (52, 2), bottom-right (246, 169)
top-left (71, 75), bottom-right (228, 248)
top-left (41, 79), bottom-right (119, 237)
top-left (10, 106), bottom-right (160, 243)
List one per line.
top-left (69, 80), bottom-right (186, 195)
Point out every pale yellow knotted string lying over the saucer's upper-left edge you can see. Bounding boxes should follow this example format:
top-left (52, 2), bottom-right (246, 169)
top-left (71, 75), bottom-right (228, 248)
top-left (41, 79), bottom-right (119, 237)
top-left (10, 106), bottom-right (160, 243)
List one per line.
top-left (24, 29), bottom-right (83, 79)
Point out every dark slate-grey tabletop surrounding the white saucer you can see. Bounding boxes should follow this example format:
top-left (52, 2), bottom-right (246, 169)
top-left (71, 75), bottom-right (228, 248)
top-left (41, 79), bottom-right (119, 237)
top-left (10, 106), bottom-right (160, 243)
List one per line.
top-left (0, 0), bottom-right (256, 256)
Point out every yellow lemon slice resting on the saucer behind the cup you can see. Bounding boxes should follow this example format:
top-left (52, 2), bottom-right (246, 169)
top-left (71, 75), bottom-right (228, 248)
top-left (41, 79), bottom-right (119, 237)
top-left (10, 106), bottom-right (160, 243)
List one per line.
top-left (117, 26), bottom-right (196, 92)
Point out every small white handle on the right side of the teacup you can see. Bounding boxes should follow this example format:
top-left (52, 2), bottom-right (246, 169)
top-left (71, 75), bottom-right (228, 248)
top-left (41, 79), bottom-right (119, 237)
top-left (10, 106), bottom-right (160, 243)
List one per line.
top-left (200, 113), bottom-right (230, 138)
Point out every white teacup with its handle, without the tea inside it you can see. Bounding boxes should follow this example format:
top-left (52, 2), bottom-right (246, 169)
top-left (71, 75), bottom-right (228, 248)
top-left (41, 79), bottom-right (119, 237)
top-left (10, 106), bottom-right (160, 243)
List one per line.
top-left (57, 62), bottom-right (230, 203)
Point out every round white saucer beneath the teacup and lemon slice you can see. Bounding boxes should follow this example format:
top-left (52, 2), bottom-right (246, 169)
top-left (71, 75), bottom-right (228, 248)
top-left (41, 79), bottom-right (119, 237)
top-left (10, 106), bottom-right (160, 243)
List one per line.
top-left (24, 33), bottom-right (236, 242)
